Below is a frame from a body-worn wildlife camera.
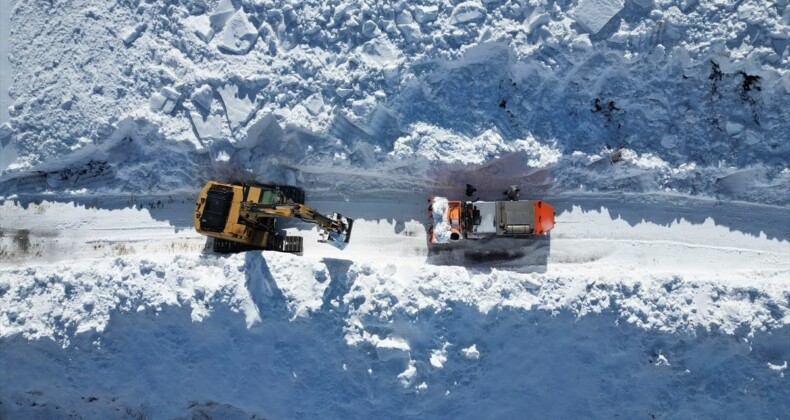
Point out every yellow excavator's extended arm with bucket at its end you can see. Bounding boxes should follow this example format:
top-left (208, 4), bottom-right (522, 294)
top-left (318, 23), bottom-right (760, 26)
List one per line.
top-left (239, 201), bottom-right (354, 243)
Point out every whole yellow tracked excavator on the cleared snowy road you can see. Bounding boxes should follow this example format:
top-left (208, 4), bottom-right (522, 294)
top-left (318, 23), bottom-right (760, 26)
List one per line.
top-left (194, 181), bottom-right (354, 253)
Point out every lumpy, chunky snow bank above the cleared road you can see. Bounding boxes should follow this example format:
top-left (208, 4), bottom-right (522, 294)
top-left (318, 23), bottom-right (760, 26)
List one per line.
top-left (0, 0), bottom-right (790, 204)
